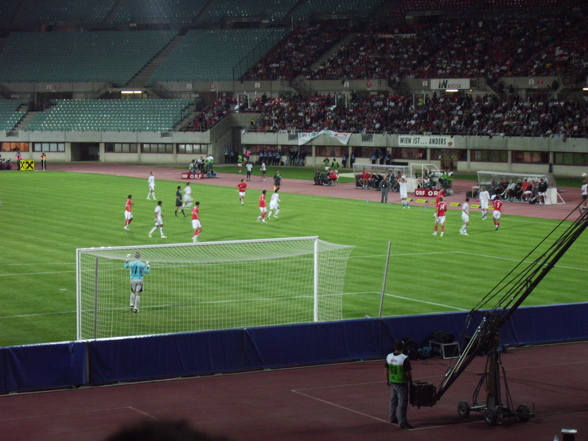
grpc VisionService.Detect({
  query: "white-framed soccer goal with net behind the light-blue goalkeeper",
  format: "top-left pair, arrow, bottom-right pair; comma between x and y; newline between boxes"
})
76,237 -> 353,340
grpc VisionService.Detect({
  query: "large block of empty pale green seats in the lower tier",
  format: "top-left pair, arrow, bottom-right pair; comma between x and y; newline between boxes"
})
27,99 -> 192,132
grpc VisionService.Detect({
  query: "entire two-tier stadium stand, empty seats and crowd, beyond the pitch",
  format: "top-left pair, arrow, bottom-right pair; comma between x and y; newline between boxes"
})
0,0 -> 588,174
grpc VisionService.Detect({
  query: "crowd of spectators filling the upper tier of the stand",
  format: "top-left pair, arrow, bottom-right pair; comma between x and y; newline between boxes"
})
242,15 -> 588,83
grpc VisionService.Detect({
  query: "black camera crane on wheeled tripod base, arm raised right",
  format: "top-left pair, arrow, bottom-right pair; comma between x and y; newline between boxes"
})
420,205 -> 588,426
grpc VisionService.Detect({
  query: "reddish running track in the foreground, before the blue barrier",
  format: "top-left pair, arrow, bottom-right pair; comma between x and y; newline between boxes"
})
0,342 -> 588,441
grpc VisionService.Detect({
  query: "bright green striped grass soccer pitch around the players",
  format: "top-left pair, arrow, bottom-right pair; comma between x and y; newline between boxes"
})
0,171 -> 588,346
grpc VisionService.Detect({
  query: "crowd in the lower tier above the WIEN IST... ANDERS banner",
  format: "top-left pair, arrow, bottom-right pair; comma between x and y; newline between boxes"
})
246,93 -> 588,137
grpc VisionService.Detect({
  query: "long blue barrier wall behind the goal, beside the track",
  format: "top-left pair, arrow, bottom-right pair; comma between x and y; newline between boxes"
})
0,303 -> 588,393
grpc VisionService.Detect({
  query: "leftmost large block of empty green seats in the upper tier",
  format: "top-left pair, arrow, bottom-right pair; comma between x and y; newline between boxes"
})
0,31 -> 177,86
